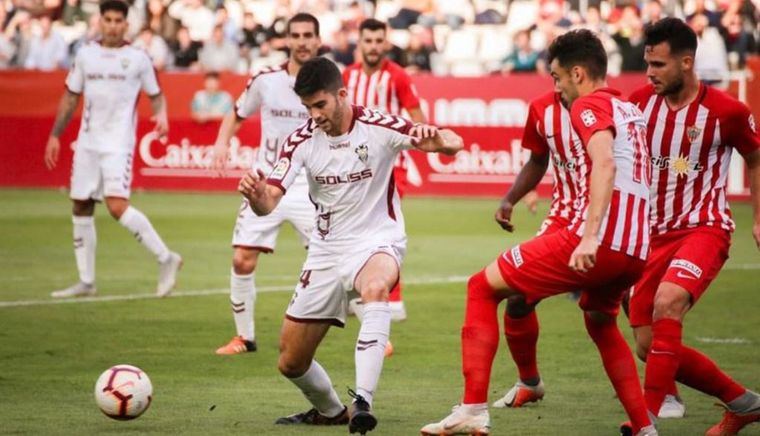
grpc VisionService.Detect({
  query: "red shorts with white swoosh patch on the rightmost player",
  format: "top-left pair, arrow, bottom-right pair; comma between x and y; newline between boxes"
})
629,227 -> 731,327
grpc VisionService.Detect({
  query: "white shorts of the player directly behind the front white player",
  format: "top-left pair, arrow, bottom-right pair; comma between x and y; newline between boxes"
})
232,192 -> 315,253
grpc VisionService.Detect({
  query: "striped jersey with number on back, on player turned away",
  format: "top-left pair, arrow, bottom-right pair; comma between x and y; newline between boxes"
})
570,88 -> 651,260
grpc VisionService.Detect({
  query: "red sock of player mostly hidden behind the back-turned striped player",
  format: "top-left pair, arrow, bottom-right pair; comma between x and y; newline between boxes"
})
504,310 -> 538,380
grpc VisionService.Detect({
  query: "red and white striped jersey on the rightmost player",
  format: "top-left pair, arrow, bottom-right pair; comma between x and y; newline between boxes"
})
631,85 -> 760,235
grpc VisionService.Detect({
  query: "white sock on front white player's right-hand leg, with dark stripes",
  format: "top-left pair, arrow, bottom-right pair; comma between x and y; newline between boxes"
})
354,302 -> 391,405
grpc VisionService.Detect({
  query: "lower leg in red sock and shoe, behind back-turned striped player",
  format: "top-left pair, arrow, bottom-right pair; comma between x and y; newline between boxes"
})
493,294 -> 544,408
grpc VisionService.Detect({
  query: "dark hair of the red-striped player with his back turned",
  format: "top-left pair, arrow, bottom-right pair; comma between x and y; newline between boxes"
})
549,29 -> 607,80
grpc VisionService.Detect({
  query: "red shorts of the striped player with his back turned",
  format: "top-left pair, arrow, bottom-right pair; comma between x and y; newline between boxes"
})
497,229 -> 644,316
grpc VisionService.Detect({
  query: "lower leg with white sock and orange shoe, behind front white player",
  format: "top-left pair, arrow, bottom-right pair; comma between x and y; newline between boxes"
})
216,245 -> 261,355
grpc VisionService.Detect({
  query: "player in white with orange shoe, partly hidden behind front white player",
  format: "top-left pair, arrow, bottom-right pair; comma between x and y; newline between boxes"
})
213,13 -> 322,355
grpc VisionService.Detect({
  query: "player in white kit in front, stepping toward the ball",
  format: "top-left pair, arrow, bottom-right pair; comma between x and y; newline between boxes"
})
238,58 -> 463,434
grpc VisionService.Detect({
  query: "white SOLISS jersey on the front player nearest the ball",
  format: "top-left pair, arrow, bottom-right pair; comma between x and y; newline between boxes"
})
267,106 -> 413,269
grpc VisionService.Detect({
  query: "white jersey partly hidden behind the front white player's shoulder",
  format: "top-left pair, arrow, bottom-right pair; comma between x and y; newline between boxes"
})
235,63 -> 309,190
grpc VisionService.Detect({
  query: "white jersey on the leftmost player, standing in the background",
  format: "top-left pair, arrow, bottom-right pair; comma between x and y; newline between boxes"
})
66,42 -> 161,152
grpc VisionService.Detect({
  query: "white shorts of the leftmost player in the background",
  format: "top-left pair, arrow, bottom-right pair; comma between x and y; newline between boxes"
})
69,148 -> 132,201
